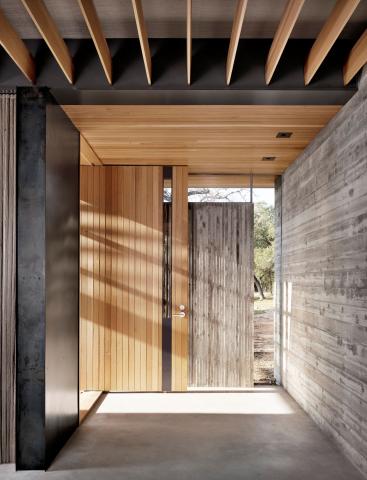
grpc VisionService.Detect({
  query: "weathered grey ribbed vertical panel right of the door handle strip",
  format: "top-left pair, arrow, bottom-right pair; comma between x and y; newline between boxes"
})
190,203 -> 254,388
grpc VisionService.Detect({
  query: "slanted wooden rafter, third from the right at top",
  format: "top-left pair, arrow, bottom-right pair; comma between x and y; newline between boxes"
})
265,0 -> 305,85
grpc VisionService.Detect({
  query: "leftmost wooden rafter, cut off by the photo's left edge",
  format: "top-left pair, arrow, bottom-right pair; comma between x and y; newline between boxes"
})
0,10 -> 36,83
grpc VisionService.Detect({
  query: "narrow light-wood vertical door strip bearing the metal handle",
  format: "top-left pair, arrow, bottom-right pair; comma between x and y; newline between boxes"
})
171,167 -> 191,391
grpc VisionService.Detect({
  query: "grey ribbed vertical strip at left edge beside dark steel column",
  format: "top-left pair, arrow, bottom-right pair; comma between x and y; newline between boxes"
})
0,92 -> 16,463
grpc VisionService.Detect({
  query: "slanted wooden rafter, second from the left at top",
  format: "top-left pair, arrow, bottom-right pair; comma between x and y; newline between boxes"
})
22,0 -> 74,84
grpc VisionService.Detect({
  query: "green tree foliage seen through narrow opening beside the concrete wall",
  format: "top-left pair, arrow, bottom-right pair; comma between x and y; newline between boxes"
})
254,203 -> 275,292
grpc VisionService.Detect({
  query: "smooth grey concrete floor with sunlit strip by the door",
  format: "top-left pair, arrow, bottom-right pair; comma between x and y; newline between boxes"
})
0,387 -> 363,480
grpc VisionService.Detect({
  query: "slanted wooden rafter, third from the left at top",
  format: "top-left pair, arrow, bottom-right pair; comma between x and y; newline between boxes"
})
78,0 -> 112,85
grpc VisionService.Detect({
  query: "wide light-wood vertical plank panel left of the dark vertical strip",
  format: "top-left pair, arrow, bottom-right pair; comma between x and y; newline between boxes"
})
80,166 -> 163,391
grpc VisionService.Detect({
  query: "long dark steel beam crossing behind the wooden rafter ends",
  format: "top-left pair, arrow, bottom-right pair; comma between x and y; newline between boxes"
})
0,39 -> 357,104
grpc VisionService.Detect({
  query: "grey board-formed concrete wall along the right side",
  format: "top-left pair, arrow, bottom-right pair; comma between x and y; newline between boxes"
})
276,68 -> 367,474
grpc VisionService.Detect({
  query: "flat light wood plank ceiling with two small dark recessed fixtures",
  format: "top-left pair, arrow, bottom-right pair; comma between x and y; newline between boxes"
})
63,105 -> 340,186
